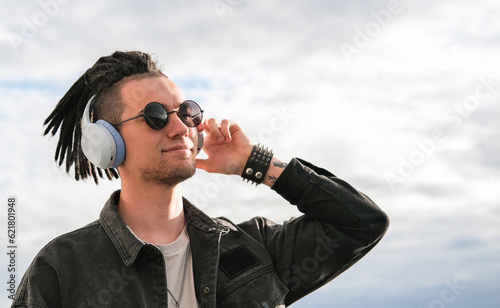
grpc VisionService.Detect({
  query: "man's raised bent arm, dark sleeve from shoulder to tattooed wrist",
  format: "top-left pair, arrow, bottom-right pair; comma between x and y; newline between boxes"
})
239,159 -> 388,305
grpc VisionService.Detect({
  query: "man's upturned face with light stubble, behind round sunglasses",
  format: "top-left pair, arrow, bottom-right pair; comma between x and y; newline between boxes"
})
119,76 -> 197,186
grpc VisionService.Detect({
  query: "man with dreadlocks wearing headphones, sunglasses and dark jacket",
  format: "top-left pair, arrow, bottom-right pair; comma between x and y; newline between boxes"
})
12,52 -> 388,308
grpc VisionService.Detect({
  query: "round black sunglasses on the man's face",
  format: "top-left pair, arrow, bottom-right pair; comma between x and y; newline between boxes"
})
113,100 -> 203,130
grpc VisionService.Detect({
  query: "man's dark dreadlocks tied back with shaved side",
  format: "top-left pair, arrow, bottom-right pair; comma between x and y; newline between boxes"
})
44,51 -> 165,184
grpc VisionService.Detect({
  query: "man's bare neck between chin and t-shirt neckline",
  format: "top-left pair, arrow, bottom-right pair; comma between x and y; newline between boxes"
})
118,179 -> 186,244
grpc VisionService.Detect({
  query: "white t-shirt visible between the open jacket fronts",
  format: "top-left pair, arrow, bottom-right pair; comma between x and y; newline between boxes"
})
156,227 -> 199,308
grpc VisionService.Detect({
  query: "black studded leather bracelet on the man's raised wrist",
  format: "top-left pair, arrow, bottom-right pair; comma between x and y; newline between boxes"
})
241,144 -> 274,185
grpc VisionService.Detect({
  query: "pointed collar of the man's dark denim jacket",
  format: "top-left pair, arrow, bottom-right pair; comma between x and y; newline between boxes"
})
99,190 -> 220,267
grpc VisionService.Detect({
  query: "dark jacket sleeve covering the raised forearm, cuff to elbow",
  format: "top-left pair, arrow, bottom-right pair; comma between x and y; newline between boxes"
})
273,159 -> 388,243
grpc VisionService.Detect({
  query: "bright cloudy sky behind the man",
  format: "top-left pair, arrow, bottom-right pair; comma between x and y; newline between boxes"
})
0,0 -> 500,308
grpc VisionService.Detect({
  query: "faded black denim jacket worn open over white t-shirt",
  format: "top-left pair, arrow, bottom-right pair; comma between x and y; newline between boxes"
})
12,159 -> 389,308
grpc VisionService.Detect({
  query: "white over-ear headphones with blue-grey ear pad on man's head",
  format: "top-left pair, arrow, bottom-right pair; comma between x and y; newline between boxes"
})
81,95 -> 203,169
